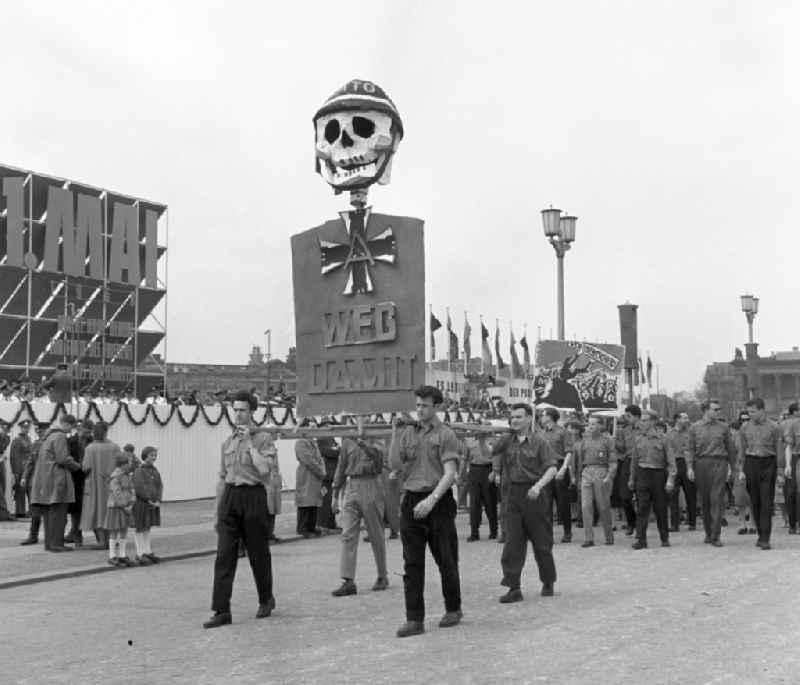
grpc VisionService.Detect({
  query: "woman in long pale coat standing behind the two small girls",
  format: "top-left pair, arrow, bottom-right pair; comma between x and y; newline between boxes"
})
81,421 -> 122,549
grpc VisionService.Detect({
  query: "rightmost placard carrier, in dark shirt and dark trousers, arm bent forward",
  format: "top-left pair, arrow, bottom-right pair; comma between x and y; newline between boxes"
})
492,403 -> 558,604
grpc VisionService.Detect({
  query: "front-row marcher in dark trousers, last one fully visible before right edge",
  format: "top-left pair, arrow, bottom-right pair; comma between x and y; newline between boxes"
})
738,397 -> 785,550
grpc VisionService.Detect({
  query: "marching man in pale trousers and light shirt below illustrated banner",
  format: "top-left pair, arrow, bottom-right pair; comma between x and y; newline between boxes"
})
573,416 -> 617,547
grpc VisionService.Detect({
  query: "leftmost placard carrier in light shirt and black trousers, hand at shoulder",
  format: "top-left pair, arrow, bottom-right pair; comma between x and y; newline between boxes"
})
203,390 -> 277,628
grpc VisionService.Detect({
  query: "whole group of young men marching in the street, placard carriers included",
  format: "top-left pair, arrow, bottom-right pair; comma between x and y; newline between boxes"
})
198,386 -> 800,637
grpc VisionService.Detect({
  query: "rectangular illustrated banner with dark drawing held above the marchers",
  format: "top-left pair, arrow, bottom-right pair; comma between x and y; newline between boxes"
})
533,340 -> 625,411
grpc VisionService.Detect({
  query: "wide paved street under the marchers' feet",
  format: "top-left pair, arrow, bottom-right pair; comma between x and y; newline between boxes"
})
0,504 -> 800,684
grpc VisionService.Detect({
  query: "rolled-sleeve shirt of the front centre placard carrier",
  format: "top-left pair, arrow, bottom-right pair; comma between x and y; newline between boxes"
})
390,416 -> 459,492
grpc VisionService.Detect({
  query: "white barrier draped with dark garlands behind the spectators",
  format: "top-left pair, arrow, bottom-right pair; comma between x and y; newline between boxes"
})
0,402 -> 297,502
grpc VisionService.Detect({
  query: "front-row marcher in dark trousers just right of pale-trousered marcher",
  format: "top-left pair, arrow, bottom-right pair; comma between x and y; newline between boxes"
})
628,409 -> 675,549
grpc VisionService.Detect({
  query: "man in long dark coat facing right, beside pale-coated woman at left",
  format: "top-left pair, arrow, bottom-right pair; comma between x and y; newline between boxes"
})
31,414 -> 81,552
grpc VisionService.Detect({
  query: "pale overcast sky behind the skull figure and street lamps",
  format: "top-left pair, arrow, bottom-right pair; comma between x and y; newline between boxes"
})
0,0 -> 800,392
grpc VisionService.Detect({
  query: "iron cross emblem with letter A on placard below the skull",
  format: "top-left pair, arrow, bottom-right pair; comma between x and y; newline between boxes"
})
319,207 -> 397,295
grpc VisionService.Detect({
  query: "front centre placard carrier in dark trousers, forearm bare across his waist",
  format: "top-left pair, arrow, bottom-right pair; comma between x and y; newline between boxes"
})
390,385 -> 462,637
